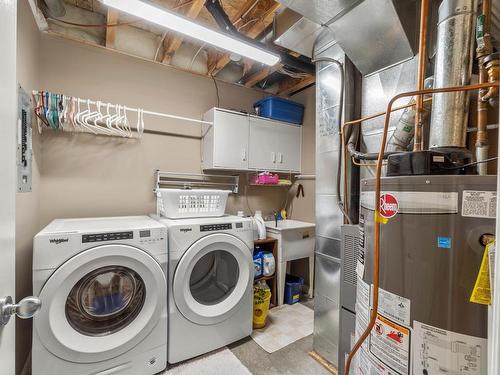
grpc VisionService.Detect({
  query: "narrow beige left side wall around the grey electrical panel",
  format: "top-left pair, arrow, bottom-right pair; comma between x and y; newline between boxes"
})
16,0 -> 41,373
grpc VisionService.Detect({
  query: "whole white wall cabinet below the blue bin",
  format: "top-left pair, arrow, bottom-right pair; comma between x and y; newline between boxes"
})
202,108 -> 302,173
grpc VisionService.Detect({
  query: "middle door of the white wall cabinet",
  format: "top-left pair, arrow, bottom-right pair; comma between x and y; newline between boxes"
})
248,117 -> 277,171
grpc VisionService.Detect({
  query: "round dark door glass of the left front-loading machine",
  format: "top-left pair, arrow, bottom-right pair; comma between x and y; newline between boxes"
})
66,266 -> 146,336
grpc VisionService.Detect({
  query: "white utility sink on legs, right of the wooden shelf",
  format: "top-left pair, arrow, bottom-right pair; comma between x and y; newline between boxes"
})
265,220 -> 316,305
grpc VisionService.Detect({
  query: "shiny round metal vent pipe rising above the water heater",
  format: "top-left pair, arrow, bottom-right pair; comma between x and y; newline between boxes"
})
429,0 -> 477,148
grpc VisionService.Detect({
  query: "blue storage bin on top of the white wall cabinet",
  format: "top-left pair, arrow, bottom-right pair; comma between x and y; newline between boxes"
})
254,96 -> 304,125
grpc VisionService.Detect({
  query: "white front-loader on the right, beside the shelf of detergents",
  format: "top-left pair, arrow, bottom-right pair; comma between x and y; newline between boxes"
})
151,216 -> 254,363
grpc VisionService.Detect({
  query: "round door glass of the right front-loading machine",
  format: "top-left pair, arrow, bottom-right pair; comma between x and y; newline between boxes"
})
189,250 -> 240,305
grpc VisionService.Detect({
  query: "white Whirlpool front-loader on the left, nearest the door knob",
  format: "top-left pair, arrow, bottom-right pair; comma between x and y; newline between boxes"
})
32,216 -> 168,375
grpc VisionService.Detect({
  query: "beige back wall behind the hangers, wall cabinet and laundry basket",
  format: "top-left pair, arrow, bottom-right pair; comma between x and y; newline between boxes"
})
40,35 -> 314,225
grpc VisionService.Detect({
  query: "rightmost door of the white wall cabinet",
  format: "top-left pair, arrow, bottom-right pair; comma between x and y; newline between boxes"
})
275,123 -> 302,172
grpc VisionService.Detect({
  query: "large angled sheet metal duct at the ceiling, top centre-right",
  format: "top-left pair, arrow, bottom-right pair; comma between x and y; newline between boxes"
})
279,0 -> 418,75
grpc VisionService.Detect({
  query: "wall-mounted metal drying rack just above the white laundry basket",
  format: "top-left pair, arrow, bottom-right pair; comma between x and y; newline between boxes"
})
154,170 -> 240,194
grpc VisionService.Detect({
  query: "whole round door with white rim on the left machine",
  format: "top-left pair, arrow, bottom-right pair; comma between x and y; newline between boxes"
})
34,245 -> 167,363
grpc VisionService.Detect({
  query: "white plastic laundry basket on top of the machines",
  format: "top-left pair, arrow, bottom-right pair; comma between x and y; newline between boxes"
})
156,189 -> 231,219
